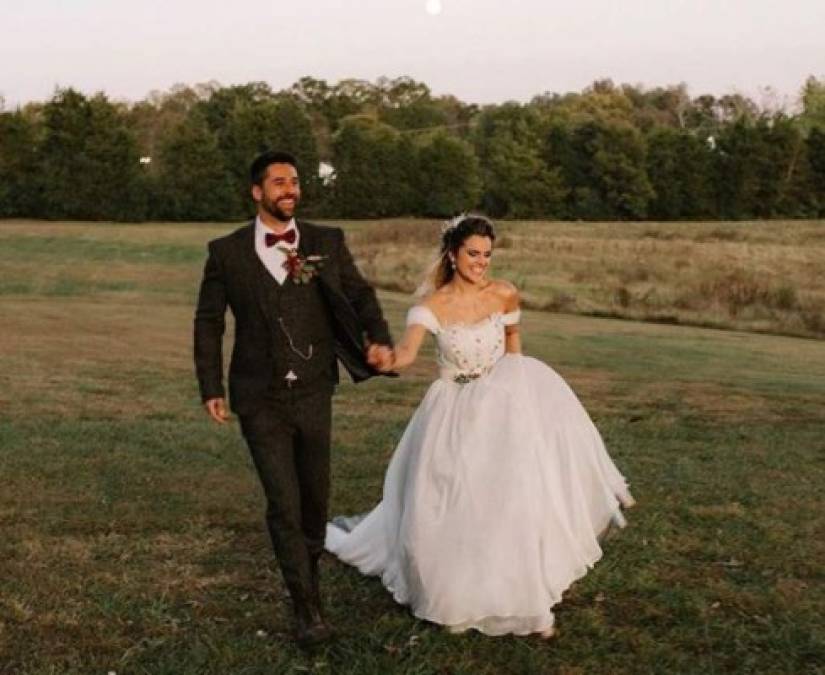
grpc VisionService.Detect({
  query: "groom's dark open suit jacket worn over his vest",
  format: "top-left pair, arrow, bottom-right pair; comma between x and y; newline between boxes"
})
195,221 -> 392,415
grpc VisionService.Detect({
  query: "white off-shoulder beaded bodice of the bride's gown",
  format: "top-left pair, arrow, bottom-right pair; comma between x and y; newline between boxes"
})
407,305 -> 521,384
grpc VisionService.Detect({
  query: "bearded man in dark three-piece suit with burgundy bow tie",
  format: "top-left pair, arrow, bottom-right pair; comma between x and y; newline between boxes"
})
195,151 -> 391,644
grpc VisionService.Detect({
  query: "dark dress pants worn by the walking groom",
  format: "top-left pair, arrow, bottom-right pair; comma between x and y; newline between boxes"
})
240,385 -> 333,604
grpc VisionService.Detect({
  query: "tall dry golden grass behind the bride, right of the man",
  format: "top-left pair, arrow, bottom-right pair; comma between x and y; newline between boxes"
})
348,220 -> 825,337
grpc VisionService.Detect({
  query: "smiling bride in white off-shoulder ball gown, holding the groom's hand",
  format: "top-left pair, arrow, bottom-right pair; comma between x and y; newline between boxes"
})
326,215 -> 633,637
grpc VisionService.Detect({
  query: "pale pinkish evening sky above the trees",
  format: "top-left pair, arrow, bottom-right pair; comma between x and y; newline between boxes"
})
0,0 -> 825,109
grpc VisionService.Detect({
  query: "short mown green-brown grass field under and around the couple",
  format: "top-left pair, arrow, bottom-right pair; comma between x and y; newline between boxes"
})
0,222 -> 825,675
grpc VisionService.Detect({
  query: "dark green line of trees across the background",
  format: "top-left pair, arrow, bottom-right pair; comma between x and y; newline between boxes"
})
0,77 -> 825,221
